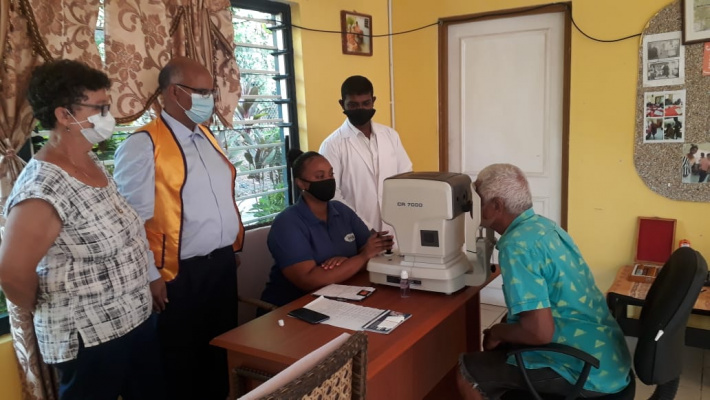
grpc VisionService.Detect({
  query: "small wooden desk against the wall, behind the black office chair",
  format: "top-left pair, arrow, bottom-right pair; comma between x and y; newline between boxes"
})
606,265 -> 710,349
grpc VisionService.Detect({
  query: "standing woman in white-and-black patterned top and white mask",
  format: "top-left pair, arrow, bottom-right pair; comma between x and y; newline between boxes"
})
0,60 -> 164,400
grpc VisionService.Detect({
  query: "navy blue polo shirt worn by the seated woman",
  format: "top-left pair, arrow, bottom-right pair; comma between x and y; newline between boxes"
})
261,199 -> 370,306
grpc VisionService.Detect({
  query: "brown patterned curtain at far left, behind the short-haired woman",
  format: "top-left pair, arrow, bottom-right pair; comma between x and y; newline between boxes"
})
0,0 -> 102,400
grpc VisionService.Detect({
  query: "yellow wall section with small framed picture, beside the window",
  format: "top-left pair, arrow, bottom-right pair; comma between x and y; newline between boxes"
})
290,0 -> 391,151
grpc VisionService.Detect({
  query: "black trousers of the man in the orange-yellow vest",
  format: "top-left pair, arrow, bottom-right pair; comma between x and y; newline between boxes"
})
158,247 -> 237,400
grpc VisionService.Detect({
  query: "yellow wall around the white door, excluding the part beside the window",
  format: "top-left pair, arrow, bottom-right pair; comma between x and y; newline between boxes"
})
392,0 -> 710,290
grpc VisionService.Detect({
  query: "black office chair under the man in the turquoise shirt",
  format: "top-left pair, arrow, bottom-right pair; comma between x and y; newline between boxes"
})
504,247 -> 708,400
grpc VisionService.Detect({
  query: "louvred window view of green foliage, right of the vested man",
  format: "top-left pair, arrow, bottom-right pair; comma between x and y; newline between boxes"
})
229,7 -> 288,225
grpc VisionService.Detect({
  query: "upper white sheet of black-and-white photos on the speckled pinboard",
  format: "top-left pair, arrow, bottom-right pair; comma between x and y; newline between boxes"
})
641,32 -> 685,87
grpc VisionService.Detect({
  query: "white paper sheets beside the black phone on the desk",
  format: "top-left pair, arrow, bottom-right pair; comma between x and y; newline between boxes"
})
304,297 -> 412,333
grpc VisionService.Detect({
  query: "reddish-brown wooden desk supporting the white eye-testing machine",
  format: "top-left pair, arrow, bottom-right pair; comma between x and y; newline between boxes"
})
211,272 -> 498,400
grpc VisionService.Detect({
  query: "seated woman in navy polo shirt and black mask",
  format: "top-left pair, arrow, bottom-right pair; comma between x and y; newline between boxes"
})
261,150 -> 392,306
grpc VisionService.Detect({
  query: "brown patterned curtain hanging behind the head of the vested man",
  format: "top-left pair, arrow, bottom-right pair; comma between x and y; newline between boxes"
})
105,0 -> 241,126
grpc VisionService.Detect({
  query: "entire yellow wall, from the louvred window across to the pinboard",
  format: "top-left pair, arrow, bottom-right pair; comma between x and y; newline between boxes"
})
291,0 -> 710,290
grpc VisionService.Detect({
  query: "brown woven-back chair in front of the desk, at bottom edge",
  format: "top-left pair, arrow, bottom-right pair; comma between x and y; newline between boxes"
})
231,332 -> 367,400
